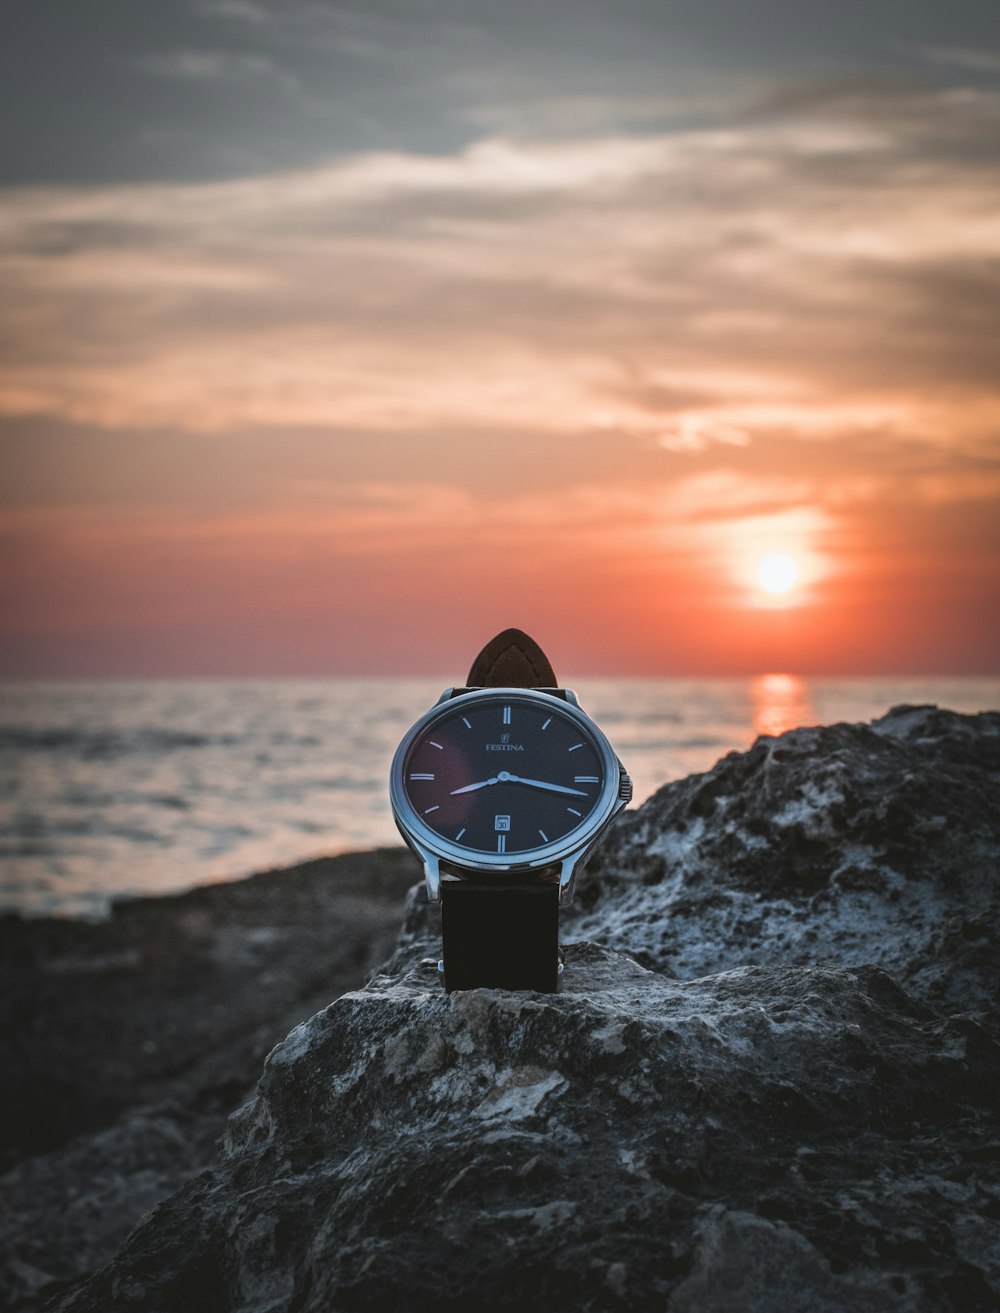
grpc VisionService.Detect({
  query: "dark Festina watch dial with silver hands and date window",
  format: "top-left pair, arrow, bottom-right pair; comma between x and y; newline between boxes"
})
403,695 -> 604,856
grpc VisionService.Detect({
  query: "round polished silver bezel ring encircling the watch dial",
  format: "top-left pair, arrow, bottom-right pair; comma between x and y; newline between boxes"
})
388,688 -> 622,874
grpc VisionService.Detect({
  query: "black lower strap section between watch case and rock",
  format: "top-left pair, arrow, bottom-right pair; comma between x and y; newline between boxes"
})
441,880 -> 559,994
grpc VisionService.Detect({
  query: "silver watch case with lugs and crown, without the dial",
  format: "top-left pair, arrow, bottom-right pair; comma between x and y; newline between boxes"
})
388,688 -> 633,903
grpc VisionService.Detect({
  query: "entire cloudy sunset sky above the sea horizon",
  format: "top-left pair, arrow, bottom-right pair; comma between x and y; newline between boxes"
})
0,0 -> 1000,680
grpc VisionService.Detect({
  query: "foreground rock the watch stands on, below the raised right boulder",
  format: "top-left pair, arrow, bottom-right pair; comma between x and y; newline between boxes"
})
54,944 -> 1000,1313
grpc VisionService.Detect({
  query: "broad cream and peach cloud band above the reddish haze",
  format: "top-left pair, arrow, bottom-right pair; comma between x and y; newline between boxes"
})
0,79 -> 1000,452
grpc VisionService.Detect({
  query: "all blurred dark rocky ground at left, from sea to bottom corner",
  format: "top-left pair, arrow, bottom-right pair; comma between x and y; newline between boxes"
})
0,848 -> 417,1308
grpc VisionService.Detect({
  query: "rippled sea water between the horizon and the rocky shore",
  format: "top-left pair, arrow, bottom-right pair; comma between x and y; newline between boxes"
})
0,675 -> 1000,916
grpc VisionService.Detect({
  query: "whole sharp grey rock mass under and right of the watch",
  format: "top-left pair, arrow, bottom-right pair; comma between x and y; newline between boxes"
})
1,708 -> 1000,1313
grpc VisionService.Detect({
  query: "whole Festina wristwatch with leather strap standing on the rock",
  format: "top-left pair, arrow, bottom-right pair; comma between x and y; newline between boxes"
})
390,629 -> 633,993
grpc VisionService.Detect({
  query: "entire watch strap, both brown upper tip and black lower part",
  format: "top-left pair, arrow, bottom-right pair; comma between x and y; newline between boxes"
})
441,629 -> 562,994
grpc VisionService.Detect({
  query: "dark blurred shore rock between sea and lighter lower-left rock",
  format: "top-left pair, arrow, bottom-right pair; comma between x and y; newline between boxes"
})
0,848 -> 417,1169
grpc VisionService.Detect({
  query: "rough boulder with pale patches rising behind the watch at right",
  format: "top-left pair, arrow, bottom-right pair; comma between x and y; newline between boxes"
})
392,706 -> 1000,1025
